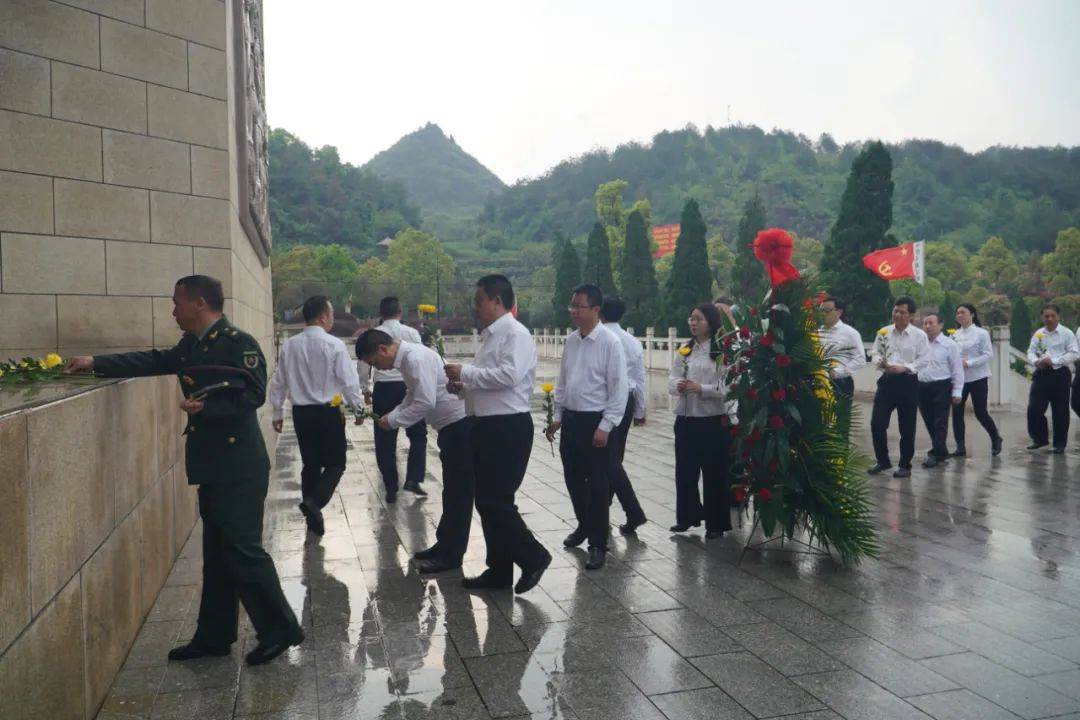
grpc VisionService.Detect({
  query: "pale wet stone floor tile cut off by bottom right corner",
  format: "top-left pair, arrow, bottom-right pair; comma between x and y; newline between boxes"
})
921,653 -> 1080,720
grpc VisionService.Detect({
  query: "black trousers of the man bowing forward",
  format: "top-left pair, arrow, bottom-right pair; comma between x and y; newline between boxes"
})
435,418 -> 476,562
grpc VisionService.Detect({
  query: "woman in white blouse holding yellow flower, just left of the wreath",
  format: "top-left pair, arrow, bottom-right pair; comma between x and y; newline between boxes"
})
667,302 -> 731,540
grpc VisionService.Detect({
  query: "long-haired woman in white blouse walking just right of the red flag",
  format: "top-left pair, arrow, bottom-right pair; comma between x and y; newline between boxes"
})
953,302 -> 1001,458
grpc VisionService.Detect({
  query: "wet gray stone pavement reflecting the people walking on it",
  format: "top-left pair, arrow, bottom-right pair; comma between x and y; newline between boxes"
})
97,367 -> 1080,720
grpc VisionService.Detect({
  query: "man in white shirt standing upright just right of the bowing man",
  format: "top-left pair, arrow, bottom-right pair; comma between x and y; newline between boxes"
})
445,275 -> 551,593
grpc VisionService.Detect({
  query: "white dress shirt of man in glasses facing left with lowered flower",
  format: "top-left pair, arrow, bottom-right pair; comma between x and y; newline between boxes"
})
555,325 -> 630,433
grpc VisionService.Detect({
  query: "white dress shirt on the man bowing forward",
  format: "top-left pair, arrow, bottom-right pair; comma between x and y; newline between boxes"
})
387,342 -> 465,430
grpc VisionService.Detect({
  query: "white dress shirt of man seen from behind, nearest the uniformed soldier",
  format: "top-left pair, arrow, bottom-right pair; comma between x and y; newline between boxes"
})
269,325 -> 364,420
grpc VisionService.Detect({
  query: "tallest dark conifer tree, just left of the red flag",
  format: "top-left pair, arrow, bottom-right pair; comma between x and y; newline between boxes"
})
821,141 -> 896,337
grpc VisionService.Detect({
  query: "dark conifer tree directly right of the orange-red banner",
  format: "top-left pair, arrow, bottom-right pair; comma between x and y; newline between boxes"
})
657,200 -> 713,335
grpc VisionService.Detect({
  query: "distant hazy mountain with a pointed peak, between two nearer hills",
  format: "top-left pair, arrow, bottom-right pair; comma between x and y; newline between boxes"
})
364,123 -> 507,216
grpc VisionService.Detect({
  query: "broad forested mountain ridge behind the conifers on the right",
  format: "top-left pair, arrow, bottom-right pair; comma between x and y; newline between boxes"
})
480,126 -> 1080,253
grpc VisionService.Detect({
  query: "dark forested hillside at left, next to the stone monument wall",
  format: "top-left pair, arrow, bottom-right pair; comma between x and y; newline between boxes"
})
269,128 -> 420,255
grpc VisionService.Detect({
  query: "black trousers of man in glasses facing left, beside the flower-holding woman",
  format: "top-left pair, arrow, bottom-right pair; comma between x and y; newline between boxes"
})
558,410 -> 613,551
